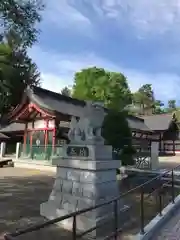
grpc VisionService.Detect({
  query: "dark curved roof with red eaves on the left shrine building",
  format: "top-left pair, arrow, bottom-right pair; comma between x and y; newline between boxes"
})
8,87 -> 86,121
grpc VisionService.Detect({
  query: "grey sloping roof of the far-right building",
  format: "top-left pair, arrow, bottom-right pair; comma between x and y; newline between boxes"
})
142,114 -> 172,130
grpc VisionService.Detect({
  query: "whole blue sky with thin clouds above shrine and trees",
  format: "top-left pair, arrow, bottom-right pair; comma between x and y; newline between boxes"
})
29,0 -> 180,104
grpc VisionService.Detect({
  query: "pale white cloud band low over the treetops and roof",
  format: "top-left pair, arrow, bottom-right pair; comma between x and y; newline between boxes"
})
30,47 -> 180,100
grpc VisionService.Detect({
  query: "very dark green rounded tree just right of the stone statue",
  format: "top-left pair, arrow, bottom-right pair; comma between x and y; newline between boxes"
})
102,110 -> 135,165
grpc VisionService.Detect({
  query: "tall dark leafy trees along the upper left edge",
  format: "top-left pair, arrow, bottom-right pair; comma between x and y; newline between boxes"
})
0,0 -> 44,114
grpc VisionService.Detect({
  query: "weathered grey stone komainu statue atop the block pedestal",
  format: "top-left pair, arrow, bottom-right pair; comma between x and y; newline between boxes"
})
68,101 -> 105,144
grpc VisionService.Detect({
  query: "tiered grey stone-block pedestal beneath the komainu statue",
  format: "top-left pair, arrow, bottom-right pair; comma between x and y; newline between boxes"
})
40,145 -> 124,238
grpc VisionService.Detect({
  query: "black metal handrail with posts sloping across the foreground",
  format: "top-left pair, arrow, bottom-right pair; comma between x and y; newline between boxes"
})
4,164 -> 180,240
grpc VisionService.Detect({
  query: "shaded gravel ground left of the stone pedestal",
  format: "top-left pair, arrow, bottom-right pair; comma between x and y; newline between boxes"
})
0,168 -> 74,240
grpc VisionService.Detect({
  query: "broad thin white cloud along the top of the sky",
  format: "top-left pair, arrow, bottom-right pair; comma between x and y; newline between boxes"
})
39,0 -> 180,38
